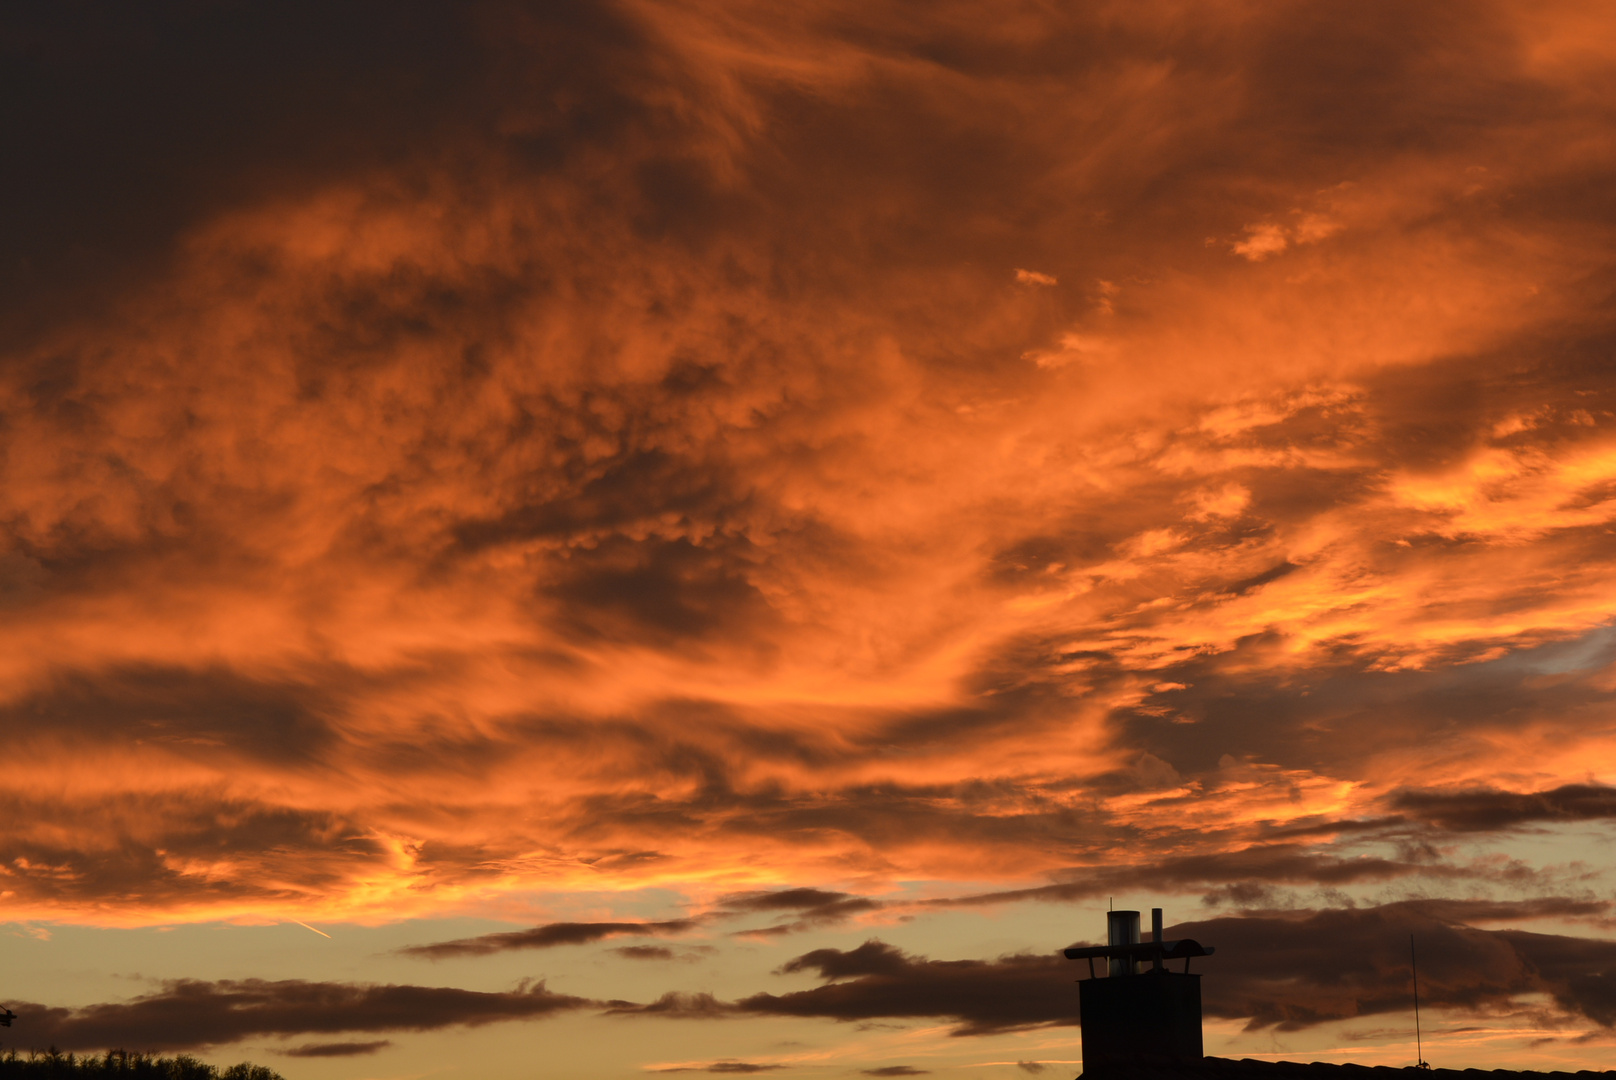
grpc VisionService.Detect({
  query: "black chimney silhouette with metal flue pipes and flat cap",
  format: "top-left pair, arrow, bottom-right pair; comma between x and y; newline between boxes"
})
1067,907 -> 1214,1072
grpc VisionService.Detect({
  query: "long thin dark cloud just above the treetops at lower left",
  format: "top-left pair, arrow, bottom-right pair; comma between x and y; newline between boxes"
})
15,978 -> 593,1053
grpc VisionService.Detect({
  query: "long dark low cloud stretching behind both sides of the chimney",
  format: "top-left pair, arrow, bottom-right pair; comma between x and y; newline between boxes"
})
609,897 -> 1616,1034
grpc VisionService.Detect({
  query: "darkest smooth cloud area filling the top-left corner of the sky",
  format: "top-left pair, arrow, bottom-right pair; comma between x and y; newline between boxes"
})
0,0 -> 632,337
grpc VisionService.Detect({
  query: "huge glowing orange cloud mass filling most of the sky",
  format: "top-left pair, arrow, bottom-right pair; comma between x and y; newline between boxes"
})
0,12 -> 1616,1041
